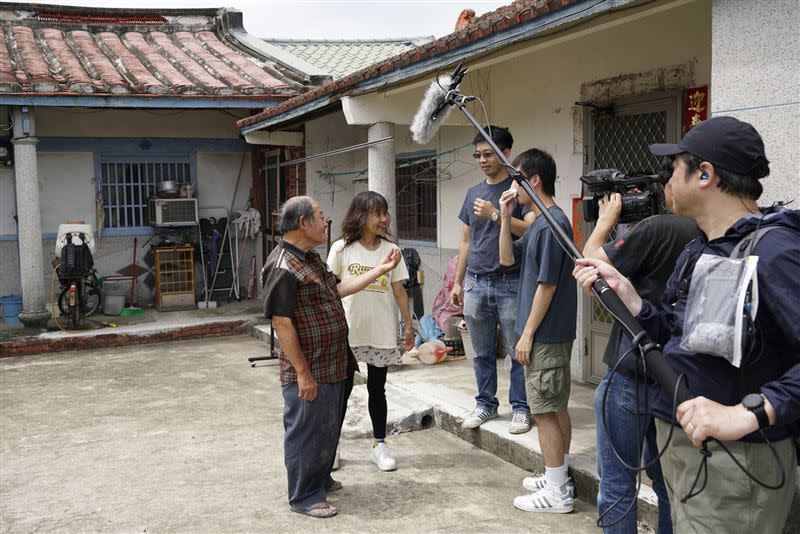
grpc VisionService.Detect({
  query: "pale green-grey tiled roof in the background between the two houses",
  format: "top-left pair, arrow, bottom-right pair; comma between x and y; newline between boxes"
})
264,36 -> 434,79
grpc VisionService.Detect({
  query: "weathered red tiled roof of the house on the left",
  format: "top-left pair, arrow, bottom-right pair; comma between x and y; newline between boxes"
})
0,3 -> 303,97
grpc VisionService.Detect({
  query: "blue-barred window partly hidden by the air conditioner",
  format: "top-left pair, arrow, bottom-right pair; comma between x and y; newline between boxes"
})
98,158 -> 191,228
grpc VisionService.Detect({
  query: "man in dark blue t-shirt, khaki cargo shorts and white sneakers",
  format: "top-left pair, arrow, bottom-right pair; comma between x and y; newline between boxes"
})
499,148 -> 578,513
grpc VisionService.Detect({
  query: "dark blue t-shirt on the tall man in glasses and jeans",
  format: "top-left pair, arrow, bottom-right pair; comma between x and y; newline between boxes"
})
458,176 -> 531,274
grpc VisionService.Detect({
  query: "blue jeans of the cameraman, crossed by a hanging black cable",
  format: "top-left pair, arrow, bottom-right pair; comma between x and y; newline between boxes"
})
594,369 -> 672,534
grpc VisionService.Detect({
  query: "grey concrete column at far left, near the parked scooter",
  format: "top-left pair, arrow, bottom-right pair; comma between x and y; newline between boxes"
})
11,108 -> 50,328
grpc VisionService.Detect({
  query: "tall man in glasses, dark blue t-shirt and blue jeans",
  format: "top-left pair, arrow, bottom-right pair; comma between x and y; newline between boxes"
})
450,126 -> 533,434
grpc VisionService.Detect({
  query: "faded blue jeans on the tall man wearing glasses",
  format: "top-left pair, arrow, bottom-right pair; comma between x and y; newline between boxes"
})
464,273 -> 530,413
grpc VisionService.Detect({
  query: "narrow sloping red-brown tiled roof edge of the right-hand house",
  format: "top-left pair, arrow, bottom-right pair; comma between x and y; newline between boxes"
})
236,0 -> 584,128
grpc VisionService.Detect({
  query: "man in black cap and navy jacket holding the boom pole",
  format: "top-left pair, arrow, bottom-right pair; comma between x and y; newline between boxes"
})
574,117 -> 800,532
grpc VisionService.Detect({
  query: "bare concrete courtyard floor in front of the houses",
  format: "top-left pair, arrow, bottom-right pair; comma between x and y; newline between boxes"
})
0,336 -> 598,534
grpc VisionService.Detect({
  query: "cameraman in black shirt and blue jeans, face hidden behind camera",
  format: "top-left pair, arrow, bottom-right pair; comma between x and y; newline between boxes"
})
583,187 -> 699,534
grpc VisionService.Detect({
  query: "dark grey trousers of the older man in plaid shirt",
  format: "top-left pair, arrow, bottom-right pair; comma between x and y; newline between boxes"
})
283,380 -> 345,509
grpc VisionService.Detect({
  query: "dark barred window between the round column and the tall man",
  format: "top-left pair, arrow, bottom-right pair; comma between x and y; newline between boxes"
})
396,152 -> 437,241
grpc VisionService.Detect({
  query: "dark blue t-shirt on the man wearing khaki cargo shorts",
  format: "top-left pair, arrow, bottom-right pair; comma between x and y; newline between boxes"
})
514,206 -> 578,343
